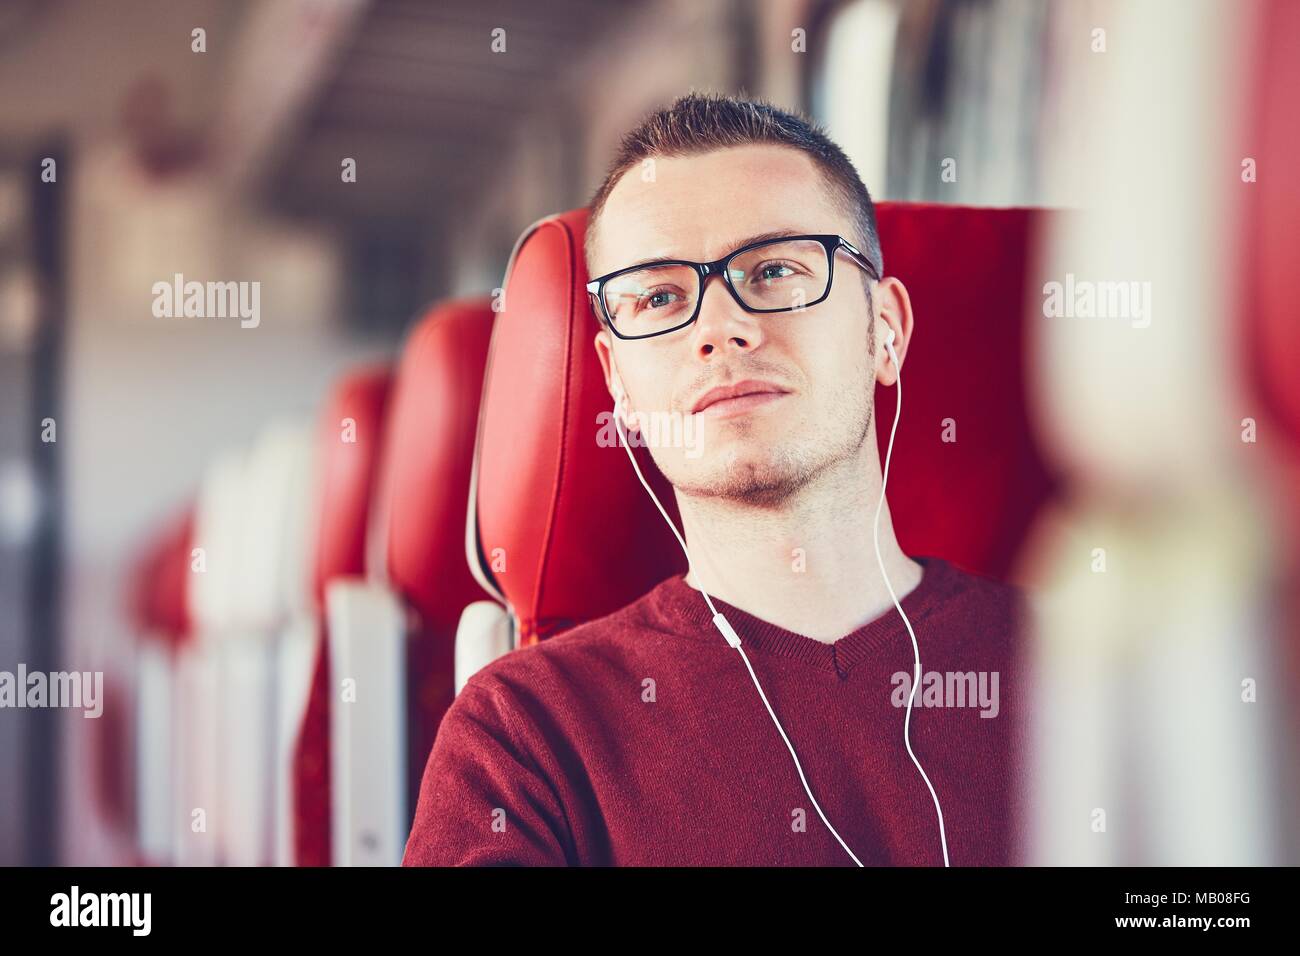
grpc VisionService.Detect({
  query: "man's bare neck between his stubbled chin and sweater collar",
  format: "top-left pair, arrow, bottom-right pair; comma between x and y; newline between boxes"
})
677,441 -> 922,644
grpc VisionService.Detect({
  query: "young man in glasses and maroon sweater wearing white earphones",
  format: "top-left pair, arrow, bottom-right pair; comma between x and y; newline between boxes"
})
404,95 -> 1022,866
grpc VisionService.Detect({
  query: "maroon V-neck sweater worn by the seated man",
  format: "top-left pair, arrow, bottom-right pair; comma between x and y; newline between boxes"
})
403,558 -> 1024,866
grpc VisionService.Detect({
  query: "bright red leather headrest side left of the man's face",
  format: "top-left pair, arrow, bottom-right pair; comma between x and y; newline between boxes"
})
472,209 -> 686,645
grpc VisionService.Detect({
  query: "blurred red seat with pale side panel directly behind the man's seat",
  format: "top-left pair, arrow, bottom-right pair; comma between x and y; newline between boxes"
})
326,298 -> 494,865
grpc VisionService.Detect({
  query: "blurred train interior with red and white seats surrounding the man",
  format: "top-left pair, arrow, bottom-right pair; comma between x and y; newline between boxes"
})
0,0 -> 1300,866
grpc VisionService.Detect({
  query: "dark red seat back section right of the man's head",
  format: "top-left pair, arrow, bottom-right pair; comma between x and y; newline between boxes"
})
876,203 -> 1057,578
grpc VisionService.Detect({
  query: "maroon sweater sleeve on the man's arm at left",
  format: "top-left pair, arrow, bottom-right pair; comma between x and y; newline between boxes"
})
402,680 -> 573,866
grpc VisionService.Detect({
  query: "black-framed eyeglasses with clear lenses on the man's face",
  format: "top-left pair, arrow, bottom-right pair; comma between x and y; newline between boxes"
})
586,235 -> 880,338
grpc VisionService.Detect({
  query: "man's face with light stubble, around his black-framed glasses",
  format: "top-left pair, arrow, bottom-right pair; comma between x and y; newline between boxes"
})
589,144 -> 875,505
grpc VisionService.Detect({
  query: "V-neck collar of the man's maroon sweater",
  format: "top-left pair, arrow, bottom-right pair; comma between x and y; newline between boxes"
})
646,555 -> 958,678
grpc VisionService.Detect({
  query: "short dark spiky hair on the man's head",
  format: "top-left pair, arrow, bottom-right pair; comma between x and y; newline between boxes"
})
584,92 -> 884,276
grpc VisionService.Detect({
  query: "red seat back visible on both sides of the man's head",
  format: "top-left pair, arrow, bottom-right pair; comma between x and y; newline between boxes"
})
475,203 -> 1054,644
